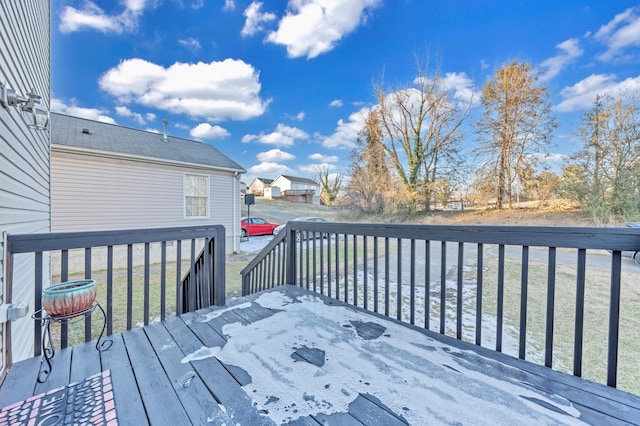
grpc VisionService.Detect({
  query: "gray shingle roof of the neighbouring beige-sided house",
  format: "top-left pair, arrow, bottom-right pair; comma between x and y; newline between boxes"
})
50,113 -> 246,173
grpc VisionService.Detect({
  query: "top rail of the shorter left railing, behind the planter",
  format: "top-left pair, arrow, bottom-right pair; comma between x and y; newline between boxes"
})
7,225 -> 224,254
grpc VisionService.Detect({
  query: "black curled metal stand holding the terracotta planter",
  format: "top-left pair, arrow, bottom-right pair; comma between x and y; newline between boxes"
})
32,302 -> 113,383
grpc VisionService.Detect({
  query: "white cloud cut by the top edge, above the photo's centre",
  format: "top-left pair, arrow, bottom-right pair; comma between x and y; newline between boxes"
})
267,0 -> 381,59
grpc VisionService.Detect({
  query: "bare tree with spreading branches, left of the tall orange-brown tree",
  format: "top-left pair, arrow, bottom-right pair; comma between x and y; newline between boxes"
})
374,59 -> 472,210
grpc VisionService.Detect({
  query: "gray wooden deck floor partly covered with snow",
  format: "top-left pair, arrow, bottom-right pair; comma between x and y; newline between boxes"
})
0,286 -> 640,425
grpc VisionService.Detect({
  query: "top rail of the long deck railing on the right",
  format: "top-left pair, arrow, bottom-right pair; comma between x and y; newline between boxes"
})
282,221 -> 640,250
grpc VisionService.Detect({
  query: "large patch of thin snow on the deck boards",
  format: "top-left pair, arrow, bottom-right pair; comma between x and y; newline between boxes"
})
210,291 -> 582,424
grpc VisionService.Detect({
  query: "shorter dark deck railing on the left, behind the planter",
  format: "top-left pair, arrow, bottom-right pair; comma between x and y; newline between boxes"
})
6,225 -> 225,362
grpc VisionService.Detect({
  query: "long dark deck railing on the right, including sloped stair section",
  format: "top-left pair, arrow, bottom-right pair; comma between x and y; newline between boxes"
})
241,221 -> 640,387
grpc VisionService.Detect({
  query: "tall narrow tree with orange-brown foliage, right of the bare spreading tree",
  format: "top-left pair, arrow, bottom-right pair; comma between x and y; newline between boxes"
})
476,61 -> 557,209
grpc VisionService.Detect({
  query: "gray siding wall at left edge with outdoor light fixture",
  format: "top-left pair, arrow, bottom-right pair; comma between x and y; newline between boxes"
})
0,0 -> 50,364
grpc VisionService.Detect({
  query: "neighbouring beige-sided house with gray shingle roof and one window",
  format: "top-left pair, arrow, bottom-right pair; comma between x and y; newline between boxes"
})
51,113 -> 245,251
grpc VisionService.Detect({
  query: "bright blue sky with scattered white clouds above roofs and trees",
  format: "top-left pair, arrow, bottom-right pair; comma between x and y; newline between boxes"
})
51,0 -> 640,183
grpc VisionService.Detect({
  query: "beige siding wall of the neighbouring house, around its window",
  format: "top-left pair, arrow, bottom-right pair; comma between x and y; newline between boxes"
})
51,151 -> 240,252
